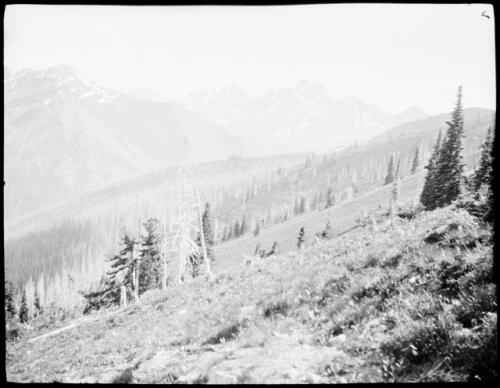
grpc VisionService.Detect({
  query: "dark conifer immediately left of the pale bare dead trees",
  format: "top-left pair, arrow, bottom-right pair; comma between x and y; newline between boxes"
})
139,218 -> 162,294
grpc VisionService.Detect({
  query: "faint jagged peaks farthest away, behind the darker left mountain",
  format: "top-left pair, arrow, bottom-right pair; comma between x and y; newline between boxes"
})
182,81 -> 427,155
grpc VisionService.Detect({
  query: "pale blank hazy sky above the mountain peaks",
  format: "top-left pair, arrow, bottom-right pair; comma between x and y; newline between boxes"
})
4,4 -> 495,113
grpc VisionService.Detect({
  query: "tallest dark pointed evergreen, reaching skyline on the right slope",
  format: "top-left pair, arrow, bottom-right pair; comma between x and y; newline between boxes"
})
435,86 -> 465,207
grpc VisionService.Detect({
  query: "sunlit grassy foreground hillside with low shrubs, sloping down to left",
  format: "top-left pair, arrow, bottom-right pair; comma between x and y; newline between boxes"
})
6,200 -> 497,384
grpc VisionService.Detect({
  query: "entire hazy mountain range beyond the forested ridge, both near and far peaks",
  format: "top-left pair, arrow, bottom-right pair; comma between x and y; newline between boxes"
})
4,65 -> 490,224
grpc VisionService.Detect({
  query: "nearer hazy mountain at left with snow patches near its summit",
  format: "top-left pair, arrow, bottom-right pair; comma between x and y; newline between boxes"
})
4,66 -> 243,218
